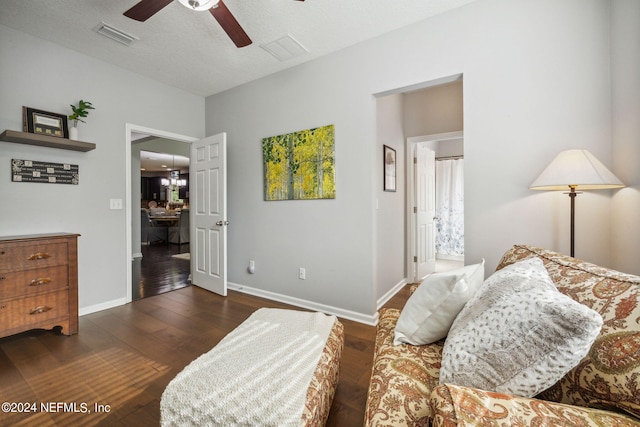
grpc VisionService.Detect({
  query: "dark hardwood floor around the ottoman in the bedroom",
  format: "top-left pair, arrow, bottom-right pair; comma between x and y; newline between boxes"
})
0,276 -> 408,427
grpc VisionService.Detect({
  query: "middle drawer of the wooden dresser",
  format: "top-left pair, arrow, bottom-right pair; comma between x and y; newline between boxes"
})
0,265 -> 69,300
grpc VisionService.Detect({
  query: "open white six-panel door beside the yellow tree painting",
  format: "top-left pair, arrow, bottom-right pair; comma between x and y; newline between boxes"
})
189,133 -> 228,296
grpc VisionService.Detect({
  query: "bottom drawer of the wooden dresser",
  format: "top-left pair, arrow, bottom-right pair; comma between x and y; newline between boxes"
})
0,291 -> 69,330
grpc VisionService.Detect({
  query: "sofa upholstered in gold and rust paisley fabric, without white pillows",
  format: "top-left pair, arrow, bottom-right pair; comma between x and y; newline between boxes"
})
364,245 -> 640,427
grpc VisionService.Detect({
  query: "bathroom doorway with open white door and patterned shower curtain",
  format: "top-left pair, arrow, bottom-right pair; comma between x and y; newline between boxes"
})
405,131 -> 464,282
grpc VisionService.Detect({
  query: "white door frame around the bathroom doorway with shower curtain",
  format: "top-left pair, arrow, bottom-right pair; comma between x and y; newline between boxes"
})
404,131 -> 464,283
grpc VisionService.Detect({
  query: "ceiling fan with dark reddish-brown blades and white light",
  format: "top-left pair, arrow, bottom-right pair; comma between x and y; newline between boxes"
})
124,0 -> 304,47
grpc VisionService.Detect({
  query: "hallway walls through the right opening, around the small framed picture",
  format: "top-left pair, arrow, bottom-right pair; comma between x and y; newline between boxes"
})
374,74 -> 464,307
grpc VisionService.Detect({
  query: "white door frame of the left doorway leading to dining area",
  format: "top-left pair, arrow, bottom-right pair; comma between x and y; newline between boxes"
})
125,123 -> 200,303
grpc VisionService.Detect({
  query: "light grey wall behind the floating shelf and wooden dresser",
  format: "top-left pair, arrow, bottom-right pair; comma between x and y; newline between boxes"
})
0,25 -> 204,312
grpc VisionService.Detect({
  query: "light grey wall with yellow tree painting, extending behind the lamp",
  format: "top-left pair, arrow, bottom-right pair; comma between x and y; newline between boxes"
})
206,0 -> 611,316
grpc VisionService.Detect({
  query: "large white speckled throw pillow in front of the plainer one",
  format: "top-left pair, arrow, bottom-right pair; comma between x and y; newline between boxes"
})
440,258 -> 602,397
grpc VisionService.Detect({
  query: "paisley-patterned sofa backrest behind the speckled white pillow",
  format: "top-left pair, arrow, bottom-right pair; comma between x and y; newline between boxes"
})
496,245 -> 640,419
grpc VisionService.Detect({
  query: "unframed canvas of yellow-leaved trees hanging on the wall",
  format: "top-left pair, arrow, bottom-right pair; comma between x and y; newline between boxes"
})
262,125 -> 336,200
